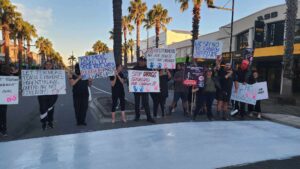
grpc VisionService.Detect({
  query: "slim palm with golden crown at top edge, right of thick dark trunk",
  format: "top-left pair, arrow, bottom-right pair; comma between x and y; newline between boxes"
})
128,0 -> 147,58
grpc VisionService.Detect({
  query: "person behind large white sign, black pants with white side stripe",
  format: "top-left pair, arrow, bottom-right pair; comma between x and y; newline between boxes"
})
38,61 -> 58,130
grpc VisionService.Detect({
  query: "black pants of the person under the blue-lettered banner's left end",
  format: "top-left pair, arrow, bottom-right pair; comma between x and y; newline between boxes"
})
73,95 -> 89,124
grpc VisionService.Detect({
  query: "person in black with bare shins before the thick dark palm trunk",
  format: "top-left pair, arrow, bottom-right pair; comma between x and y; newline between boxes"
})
109,64 -> 126,123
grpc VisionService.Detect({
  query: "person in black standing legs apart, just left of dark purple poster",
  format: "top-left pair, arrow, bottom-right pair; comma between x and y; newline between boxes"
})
169,64 -> 188,116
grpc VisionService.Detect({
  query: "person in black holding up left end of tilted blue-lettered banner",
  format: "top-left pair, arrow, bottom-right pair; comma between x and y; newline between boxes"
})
69,63 -> 92,126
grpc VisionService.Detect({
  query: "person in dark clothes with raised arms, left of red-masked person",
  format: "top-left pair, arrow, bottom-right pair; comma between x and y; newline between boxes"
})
216,62 -> 233,120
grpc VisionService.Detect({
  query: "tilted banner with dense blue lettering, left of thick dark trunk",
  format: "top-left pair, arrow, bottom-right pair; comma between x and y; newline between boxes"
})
78,53 -> 116,80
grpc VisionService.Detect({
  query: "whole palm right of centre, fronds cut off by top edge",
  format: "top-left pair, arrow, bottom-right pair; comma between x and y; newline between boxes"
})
175,0 -> 213,60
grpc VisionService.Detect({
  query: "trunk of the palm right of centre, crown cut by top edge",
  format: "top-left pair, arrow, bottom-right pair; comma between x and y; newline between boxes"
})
192,0 -> 202,60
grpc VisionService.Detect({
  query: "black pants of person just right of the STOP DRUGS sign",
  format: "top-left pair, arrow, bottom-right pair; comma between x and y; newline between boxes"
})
150,93 -> 167,117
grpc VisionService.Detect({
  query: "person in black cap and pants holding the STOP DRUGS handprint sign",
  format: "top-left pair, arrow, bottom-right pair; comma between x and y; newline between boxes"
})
133,57 -> 155,123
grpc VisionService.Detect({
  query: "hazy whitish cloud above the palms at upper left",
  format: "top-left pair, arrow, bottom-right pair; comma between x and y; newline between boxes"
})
14,3 -> 53,35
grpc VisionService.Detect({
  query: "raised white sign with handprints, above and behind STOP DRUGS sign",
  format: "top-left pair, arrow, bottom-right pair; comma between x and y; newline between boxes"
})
146,48 -> 176,69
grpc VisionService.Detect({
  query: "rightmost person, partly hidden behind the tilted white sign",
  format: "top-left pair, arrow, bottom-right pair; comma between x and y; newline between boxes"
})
248,70 -> 262,119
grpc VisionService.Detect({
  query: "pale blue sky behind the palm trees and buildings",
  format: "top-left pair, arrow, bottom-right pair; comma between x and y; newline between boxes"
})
11,0 -> 285,63
